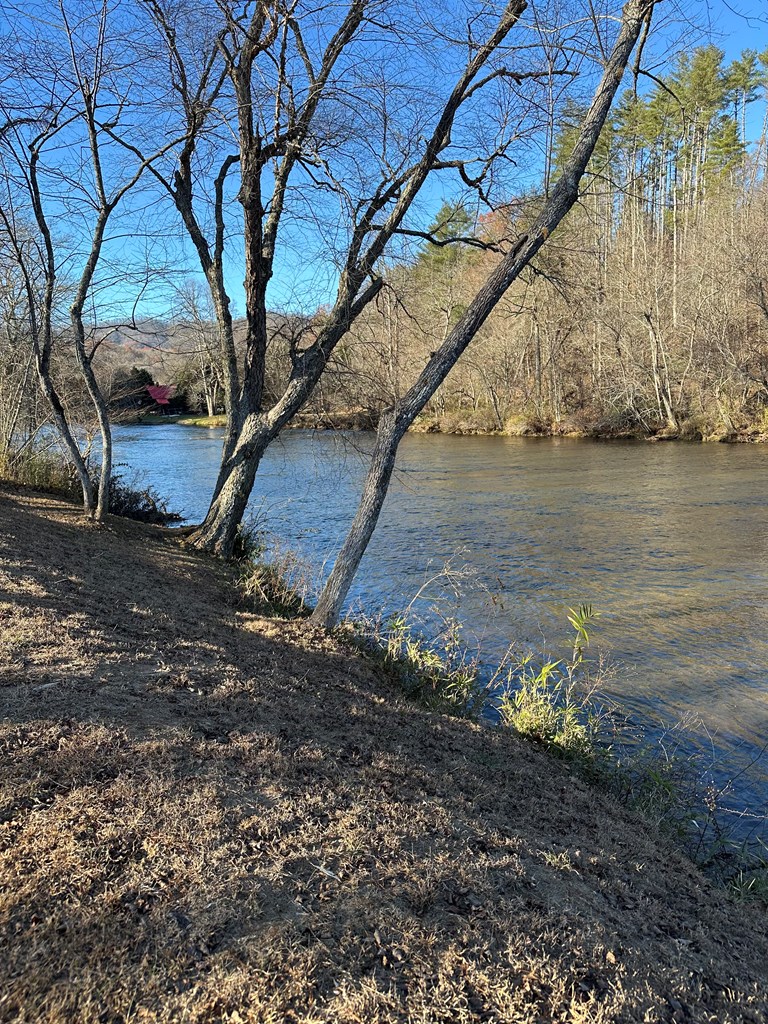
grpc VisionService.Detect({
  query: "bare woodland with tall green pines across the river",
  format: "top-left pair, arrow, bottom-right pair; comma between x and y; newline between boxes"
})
2,37 -> 768,444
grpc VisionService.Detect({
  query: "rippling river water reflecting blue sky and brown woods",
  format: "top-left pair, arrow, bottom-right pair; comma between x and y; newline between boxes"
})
115,424 -> 768,813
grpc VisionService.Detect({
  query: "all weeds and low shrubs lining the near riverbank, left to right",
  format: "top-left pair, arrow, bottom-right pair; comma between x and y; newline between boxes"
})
0,449 -> 768,902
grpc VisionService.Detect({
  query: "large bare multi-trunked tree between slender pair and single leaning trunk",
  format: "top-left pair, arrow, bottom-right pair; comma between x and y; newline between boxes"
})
137,0 -> 570,556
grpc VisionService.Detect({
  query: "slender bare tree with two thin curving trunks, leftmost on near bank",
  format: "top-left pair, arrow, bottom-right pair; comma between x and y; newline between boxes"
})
0,0 -> 182,519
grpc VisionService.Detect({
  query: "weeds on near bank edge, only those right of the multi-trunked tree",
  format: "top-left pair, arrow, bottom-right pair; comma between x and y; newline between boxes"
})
236,544 -> 768,906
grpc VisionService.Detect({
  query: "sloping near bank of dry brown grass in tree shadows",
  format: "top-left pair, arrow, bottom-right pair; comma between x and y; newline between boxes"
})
0,490 -> 768,1024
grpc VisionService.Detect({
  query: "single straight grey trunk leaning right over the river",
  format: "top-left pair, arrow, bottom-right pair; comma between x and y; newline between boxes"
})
310,0 -> 655,627
